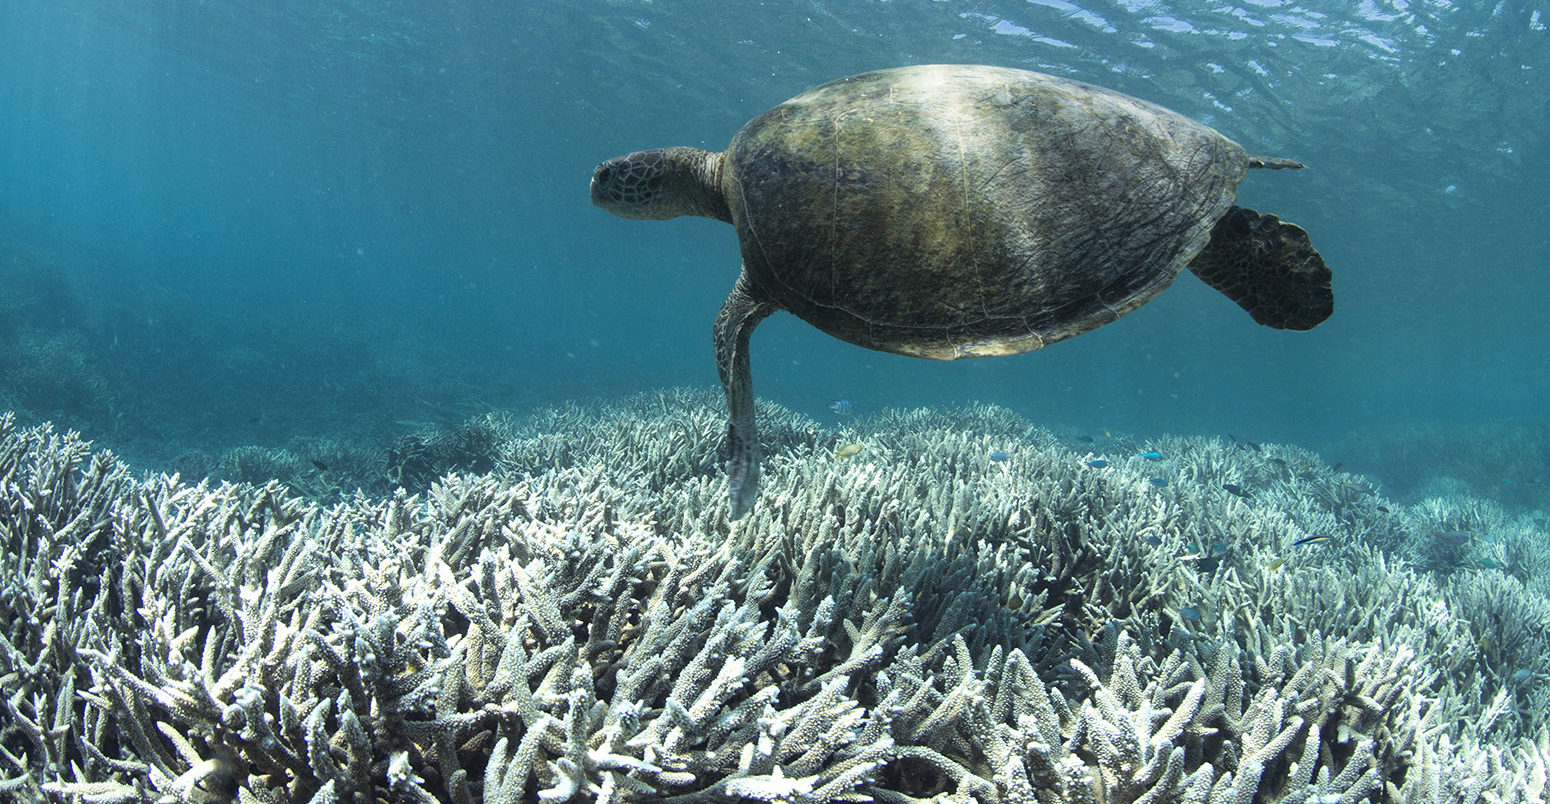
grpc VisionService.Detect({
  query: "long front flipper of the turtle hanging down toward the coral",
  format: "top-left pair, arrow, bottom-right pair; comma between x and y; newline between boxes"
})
716,274 -> 775,519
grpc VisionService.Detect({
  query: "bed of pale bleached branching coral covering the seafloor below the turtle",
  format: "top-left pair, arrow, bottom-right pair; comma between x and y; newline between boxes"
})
0,392 -> 1550,804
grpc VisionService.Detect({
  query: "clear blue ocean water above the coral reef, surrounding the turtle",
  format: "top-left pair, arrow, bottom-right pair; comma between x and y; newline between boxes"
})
0,0 -> 1550,488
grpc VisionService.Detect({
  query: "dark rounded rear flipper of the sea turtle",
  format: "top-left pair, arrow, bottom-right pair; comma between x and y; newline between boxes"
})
1189,206 -> 1335,330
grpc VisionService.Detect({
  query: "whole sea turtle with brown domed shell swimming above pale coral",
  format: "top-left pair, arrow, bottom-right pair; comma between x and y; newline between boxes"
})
592,65 -> 1335,519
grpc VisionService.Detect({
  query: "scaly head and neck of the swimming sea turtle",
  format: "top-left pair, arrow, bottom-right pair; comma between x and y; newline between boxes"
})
592,147 -> 732,222
